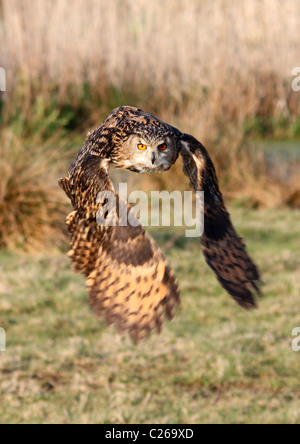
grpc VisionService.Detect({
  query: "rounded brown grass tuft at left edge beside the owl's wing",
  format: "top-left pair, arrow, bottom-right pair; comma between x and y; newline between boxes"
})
0,130 -> 65,248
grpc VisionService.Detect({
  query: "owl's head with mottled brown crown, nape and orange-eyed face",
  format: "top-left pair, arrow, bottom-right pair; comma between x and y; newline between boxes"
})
78,106 -> 183,173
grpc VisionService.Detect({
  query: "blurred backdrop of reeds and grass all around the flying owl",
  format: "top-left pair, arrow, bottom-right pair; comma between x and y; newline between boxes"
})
0,0 -> 300,423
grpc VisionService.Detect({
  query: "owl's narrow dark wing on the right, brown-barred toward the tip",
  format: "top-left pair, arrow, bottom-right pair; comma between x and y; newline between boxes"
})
181,134 -> 260,309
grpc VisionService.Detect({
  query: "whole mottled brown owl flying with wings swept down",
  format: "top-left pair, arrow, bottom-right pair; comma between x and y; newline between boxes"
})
59,106 -> 260,341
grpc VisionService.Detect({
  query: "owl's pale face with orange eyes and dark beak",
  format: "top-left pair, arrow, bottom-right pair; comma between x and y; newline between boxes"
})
116,134 -> 178,173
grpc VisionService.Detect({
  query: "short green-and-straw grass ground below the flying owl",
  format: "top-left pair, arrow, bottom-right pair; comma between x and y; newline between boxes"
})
0,208 -> 300,423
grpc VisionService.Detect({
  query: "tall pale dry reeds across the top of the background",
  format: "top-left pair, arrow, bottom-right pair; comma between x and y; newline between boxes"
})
0,0 -> 300,128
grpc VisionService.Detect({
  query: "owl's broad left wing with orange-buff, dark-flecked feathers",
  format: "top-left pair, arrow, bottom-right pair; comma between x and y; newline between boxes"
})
59,154 -> 180,341
